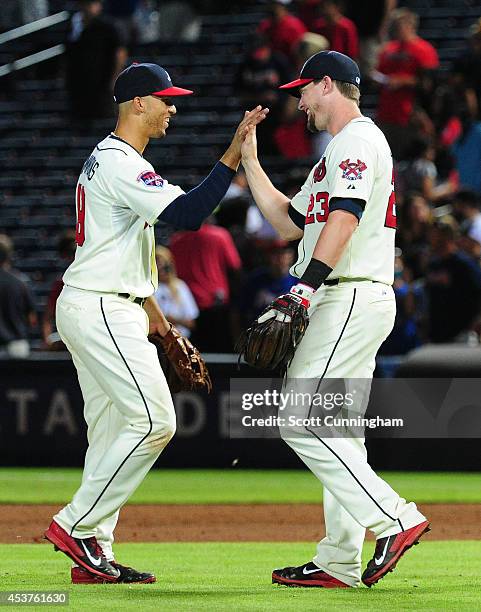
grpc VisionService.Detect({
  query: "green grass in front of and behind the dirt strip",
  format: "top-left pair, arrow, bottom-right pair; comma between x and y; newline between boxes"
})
0,468 -> 481,612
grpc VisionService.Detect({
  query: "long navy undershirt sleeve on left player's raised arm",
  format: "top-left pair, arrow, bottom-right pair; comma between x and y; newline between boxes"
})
158,161 -> 235,230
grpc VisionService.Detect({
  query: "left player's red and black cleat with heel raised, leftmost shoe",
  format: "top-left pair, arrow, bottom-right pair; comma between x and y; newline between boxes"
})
45,521 -> 120,582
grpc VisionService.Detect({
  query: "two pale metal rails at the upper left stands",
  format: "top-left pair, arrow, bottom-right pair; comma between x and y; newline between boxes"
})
0,11 -> 70,77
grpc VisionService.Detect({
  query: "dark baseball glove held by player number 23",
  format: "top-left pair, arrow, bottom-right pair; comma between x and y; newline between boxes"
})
236,293 -> 309,374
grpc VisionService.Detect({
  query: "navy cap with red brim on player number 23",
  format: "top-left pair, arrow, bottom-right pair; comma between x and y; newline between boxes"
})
279,51 -> 361,98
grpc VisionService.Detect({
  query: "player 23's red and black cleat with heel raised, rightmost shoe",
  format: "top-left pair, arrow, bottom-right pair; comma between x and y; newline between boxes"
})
362,521 -> 429,587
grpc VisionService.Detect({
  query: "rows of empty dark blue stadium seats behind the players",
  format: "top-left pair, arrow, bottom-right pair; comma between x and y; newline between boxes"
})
0,0 -> 481,350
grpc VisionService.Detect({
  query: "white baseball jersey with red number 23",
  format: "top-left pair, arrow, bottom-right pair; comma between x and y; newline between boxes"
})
291,117 -> 396,284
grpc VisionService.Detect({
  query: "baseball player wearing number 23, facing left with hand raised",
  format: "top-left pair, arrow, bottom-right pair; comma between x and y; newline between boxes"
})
242,51 -> 429,588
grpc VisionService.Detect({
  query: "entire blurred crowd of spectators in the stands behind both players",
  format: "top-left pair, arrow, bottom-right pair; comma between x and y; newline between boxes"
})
0,0 -> 481,356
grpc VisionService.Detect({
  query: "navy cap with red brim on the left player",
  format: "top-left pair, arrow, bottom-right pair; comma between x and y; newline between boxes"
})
114,64 -> 194,104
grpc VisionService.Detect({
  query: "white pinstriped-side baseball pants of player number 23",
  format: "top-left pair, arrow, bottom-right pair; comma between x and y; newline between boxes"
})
281,281 -> 425,586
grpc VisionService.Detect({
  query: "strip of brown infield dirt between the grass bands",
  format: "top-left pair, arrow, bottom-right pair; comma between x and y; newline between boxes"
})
0,504 -> 481,544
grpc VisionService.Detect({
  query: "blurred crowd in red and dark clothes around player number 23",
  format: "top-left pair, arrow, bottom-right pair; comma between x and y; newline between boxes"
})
239,0 -> 481,355
